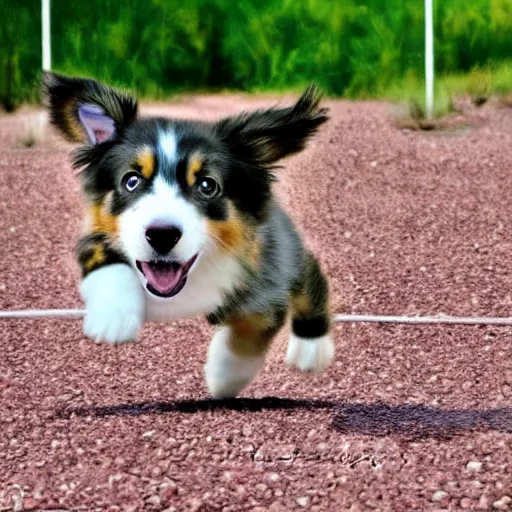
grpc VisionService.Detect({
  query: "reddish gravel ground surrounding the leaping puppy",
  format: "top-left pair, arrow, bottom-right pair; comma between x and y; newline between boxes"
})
0,96 -> 512,511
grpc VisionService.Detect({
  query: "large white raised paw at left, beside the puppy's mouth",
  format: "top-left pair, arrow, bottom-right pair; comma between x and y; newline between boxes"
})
80,263 -> 144,343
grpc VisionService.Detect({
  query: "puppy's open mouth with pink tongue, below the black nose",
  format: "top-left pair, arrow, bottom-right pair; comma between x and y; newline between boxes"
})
135,254 -> 197,298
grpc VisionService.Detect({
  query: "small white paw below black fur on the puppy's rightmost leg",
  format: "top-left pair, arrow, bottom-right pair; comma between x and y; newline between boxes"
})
285,333 -> 334,372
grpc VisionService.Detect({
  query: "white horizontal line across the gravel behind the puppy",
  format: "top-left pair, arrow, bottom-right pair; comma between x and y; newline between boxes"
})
0,309 -> 512,325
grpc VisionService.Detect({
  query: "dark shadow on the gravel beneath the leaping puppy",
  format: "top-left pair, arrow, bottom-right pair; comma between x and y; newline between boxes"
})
61,397 -> 512,440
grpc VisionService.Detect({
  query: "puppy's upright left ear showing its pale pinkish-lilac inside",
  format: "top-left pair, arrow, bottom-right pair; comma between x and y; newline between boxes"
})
42,71 -> 137,146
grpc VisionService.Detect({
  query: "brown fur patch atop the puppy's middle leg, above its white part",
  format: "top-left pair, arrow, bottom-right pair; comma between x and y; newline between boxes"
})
229,315 -> 272,357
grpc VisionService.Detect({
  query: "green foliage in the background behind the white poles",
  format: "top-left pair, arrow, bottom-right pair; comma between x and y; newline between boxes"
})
0,0 -> 512,109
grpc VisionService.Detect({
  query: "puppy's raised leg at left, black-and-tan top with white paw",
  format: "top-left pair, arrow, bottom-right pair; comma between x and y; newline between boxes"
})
77,233 -> 145,343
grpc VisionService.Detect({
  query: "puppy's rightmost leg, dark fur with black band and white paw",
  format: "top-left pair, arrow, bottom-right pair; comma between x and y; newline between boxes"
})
285,252 -> 335,372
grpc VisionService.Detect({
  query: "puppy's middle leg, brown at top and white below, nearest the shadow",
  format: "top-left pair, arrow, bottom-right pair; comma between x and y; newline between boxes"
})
204,312 -> 285,398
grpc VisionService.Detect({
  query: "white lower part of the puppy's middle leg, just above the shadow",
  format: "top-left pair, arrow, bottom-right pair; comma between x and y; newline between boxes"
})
204,327 -> 265,398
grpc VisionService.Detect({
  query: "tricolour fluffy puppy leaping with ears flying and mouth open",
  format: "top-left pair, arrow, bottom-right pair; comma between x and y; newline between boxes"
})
43,72 -> 334,398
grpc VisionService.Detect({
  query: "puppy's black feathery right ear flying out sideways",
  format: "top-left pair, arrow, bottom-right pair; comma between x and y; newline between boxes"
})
216,85 -> 329,166
